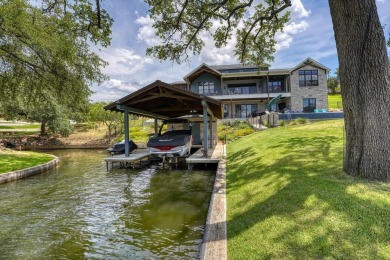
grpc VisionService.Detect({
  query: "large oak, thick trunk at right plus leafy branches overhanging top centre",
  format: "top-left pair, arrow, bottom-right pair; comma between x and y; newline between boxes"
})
146,0 -> 390,181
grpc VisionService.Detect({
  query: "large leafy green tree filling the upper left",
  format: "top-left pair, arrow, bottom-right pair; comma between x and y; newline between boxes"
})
0,0 -> 112,135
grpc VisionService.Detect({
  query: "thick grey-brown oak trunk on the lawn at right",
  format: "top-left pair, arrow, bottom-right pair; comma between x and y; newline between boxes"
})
329,0 -> 390,181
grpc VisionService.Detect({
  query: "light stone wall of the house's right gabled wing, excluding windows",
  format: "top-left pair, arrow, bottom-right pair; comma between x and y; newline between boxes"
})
290,65 -> 328,111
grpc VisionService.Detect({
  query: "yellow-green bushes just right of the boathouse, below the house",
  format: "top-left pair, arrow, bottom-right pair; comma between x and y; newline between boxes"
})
218,120 -> 254,141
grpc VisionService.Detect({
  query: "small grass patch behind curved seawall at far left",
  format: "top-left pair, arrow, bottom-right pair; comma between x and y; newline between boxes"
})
0,150 -> 54,174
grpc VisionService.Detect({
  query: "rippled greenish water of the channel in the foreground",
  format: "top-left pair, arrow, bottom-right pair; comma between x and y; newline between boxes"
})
0,150 -> 215,259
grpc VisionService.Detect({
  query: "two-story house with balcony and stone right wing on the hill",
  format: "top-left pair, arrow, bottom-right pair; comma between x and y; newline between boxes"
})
172,58 -> 329,118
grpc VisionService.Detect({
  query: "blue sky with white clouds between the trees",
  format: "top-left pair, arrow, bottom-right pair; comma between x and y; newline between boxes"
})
91,0 -> 390,102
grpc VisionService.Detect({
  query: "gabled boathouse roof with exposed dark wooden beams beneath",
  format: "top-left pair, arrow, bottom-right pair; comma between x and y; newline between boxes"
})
105,80 -> 222,119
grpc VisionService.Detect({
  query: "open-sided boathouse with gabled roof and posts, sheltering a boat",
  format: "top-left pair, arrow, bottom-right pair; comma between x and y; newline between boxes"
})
105,80 -> 222,164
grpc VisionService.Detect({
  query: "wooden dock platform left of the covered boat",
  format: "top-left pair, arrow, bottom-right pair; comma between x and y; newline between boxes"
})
104,149 -> 150,170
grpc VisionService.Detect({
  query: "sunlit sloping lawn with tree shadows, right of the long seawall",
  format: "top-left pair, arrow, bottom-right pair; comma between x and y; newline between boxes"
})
227,120 -> 390,259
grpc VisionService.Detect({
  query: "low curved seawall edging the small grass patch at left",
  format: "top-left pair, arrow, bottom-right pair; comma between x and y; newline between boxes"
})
0,157 -> 60,184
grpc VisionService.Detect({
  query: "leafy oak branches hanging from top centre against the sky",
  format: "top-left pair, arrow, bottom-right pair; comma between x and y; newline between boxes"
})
146,0 -> 291,67
